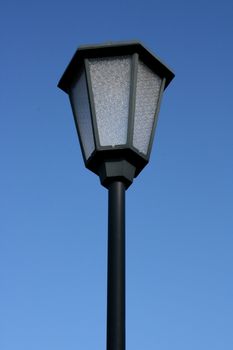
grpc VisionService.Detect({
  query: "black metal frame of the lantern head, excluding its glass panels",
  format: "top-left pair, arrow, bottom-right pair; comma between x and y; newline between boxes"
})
58,41 -> 174,188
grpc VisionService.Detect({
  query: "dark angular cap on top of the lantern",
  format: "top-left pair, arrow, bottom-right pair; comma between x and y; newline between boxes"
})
58,41 -> 175,93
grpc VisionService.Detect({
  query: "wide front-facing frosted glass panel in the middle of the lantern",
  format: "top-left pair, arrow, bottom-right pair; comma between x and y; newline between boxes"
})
89,56 -> 131,146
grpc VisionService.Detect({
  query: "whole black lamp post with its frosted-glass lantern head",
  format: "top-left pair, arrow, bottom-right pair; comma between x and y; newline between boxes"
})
58,42 -> 174,350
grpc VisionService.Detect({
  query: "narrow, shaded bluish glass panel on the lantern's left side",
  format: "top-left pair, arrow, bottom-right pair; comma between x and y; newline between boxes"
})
70,70 -> 95,159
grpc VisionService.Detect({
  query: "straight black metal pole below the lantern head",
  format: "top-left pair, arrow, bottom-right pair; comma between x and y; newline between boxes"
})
107,181 -> 125,350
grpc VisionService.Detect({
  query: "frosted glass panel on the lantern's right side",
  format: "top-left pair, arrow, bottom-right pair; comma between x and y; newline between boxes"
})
133,61 -> 162,155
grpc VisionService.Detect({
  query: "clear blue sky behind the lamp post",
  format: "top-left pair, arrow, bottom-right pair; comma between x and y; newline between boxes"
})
0,0 -> 233,350
